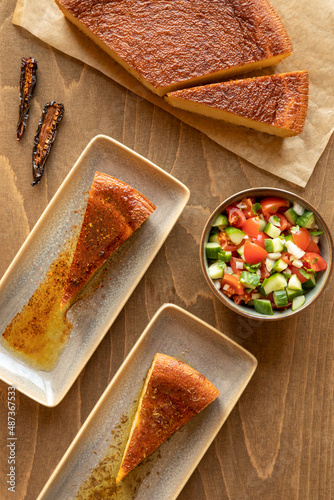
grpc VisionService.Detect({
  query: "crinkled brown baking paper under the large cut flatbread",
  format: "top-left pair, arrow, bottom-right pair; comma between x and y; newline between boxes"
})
13,0 -> 334,187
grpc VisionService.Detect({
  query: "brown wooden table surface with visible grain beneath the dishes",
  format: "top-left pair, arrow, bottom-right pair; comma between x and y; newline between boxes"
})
0,0 -> 334,500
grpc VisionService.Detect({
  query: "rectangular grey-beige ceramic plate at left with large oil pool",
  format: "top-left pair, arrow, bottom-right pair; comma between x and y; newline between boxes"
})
0,136 -> 189,406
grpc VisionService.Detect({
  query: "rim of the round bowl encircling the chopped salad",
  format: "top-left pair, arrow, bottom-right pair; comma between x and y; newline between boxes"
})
200,186 -> 333,321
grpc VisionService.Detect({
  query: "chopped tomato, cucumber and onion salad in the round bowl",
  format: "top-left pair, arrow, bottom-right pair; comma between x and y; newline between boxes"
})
205,197 -> 327,315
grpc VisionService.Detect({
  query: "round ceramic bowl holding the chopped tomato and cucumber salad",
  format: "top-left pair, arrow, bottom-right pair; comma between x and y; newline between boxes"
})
200,187 -> 333,321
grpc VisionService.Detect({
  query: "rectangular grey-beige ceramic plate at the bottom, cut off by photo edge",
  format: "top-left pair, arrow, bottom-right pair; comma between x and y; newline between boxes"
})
38,304 -> 257,500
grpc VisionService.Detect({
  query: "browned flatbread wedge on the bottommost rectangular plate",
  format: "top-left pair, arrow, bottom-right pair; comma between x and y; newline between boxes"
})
116,353 -> 219,483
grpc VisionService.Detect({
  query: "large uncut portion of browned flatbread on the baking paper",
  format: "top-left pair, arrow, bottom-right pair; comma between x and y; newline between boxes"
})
55,0 -> 292,95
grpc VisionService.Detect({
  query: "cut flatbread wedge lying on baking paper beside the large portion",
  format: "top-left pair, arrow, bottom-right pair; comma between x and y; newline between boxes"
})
165,71 -> 308,137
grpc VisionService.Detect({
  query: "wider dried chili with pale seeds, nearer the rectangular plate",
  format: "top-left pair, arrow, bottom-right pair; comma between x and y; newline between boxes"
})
32,101 -> 64,186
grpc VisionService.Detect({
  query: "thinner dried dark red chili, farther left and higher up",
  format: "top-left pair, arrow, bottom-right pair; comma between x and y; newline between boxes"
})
16,57 -> 37,141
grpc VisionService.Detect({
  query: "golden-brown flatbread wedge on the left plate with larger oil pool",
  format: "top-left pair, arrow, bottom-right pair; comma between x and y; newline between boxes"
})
61,172 -> 156,307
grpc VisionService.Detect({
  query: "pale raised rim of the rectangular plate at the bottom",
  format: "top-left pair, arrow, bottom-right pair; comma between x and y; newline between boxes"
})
36,302 -> 258,500
